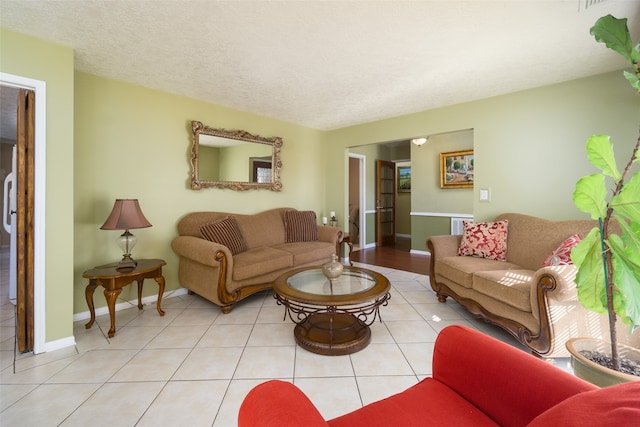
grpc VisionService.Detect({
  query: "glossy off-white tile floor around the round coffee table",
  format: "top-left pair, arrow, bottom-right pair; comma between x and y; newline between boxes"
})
0,264 -> 568,427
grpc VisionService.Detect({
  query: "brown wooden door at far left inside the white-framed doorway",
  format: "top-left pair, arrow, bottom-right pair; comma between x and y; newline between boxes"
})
15,89 -> 35,353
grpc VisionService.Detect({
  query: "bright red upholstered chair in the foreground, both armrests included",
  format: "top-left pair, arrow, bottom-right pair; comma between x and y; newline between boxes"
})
238,325 -> 640,427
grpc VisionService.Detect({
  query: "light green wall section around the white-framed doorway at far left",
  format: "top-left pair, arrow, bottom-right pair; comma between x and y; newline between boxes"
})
0,29 -> 74,342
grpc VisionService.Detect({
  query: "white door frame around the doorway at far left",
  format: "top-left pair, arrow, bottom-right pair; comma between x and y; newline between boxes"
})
0,72 -> 47,354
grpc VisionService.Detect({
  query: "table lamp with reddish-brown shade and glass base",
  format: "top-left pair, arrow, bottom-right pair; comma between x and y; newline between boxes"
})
100,199 -> 151,269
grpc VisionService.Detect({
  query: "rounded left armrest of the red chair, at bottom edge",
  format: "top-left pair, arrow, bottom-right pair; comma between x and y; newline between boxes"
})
238,380 -> 329,427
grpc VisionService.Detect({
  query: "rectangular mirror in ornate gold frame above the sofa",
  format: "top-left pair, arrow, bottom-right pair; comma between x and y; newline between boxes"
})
191,121 -> 282,191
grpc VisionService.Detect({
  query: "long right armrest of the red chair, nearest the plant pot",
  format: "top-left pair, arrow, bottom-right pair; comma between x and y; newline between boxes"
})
433,325 -> 597,425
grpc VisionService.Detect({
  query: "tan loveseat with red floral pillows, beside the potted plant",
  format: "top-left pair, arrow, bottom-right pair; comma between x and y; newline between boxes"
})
427,213 -> 640,357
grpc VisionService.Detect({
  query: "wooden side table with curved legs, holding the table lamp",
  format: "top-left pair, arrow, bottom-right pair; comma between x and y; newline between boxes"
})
82,259 -> 166,338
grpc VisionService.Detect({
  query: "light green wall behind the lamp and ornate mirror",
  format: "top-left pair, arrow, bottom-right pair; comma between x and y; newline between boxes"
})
73,72 -> 328,313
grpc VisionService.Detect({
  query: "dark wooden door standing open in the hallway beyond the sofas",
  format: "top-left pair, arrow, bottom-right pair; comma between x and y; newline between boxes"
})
376,160 -> 396,246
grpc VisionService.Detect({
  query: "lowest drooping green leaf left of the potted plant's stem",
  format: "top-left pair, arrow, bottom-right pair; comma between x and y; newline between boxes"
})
571,228 -> 607,313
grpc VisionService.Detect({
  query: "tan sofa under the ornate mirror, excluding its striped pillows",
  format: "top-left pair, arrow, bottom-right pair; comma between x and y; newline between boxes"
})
171,208 -> 343,313
